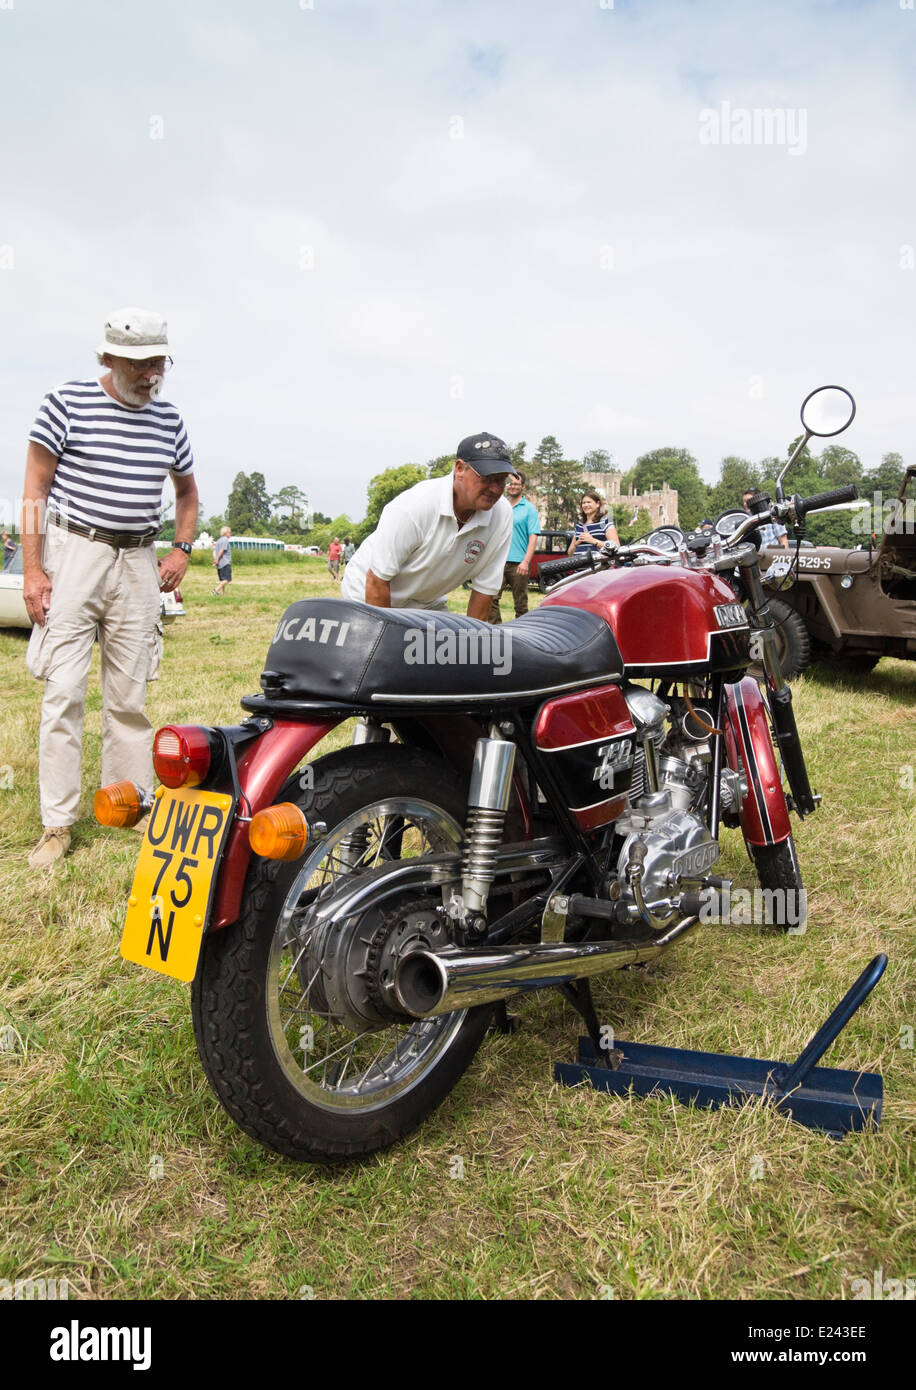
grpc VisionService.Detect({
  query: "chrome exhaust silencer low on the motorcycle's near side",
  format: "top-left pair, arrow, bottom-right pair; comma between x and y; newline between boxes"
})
395,917 -> 699,1019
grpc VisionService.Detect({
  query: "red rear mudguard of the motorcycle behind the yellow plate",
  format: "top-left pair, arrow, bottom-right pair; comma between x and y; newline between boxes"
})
208,719 -> 341,931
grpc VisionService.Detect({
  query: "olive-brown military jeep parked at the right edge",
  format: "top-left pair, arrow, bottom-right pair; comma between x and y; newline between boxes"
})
760,464 -> 916,673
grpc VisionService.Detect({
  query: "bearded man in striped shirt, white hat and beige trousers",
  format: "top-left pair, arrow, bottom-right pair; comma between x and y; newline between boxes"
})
22,309 -> 197,869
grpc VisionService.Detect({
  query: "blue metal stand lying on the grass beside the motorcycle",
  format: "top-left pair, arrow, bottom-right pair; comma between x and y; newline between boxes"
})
553,955 -> 887,1138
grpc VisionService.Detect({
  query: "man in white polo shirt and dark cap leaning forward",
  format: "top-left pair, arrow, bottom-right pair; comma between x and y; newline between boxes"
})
341,431 -> 517,621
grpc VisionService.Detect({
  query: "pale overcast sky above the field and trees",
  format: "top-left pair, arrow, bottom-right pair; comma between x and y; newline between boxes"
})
0,0 -> 916,520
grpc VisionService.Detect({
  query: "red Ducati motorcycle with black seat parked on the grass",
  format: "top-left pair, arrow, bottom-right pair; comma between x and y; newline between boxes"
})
96,388 -> 855,1162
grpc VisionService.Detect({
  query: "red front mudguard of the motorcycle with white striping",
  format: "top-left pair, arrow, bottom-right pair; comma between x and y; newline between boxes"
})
726,676 -> 792,845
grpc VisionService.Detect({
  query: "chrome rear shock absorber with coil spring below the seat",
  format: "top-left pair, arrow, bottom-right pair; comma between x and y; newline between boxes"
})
449,726 -> 516,935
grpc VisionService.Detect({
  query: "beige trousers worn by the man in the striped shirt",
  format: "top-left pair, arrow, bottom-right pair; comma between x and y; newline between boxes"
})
25,525 -> 161,826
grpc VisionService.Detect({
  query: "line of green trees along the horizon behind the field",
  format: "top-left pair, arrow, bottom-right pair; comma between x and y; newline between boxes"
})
175,435 -> 903,550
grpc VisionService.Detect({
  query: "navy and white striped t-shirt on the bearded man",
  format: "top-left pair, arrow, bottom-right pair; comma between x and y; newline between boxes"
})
29,379 -> 193,534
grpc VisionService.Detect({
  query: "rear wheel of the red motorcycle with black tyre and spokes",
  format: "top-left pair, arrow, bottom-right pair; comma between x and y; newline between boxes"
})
192,745 -> 492,1163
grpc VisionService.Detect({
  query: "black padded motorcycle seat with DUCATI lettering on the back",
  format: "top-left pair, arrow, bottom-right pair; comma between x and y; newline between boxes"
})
261,599 -> 623,705
